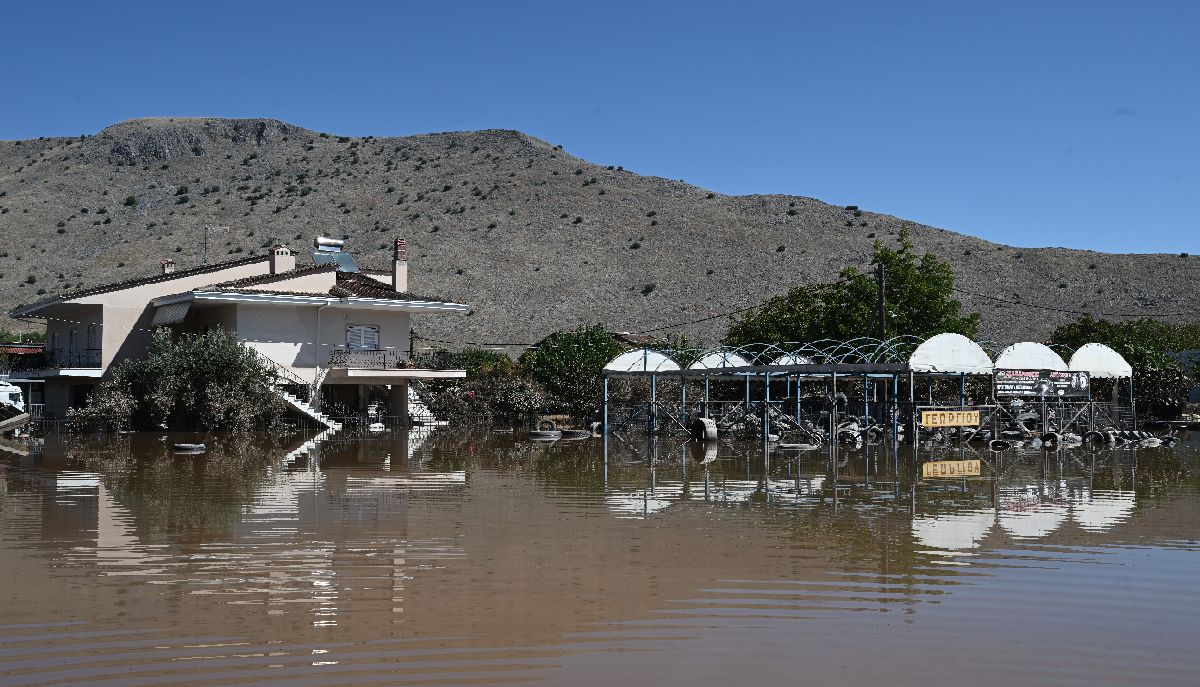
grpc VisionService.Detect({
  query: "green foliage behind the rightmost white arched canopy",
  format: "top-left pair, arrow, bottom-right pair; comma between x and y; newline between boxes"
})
1050,315 -> 1200,417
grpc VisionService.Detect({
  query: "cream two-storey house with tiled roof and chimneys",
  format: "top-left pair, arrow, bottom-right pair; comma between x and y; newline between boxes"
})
12,240 -> 468,417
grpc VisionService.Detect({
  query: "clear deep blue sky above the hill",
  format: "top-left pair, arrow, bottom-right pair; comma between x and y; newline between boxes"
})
0,0 -> 1200,253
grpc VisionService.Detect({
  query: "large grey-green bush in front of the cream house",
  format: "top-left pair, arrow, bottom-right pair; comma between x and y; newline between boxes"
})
70,329 -> 284,430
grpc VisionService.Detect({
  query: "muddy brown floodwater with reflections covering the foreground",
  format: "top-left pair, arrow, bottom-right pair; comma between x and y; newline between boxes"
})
0,429 -> 1200,687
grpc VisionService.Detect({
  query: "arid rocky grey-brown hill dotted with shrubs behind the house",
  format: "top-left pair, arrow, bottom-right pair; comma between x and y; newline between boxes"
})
0,119 -> 1200,344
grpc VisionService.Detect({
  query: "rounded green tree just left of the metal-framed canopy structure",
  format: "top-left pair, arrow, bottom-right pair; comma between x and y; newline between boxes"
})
521,324 -> 620,416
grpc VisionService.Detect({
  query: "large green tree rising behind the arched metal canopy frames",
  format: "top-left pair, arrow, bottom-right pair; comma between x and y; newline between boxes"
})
725,228 -> 979,346
